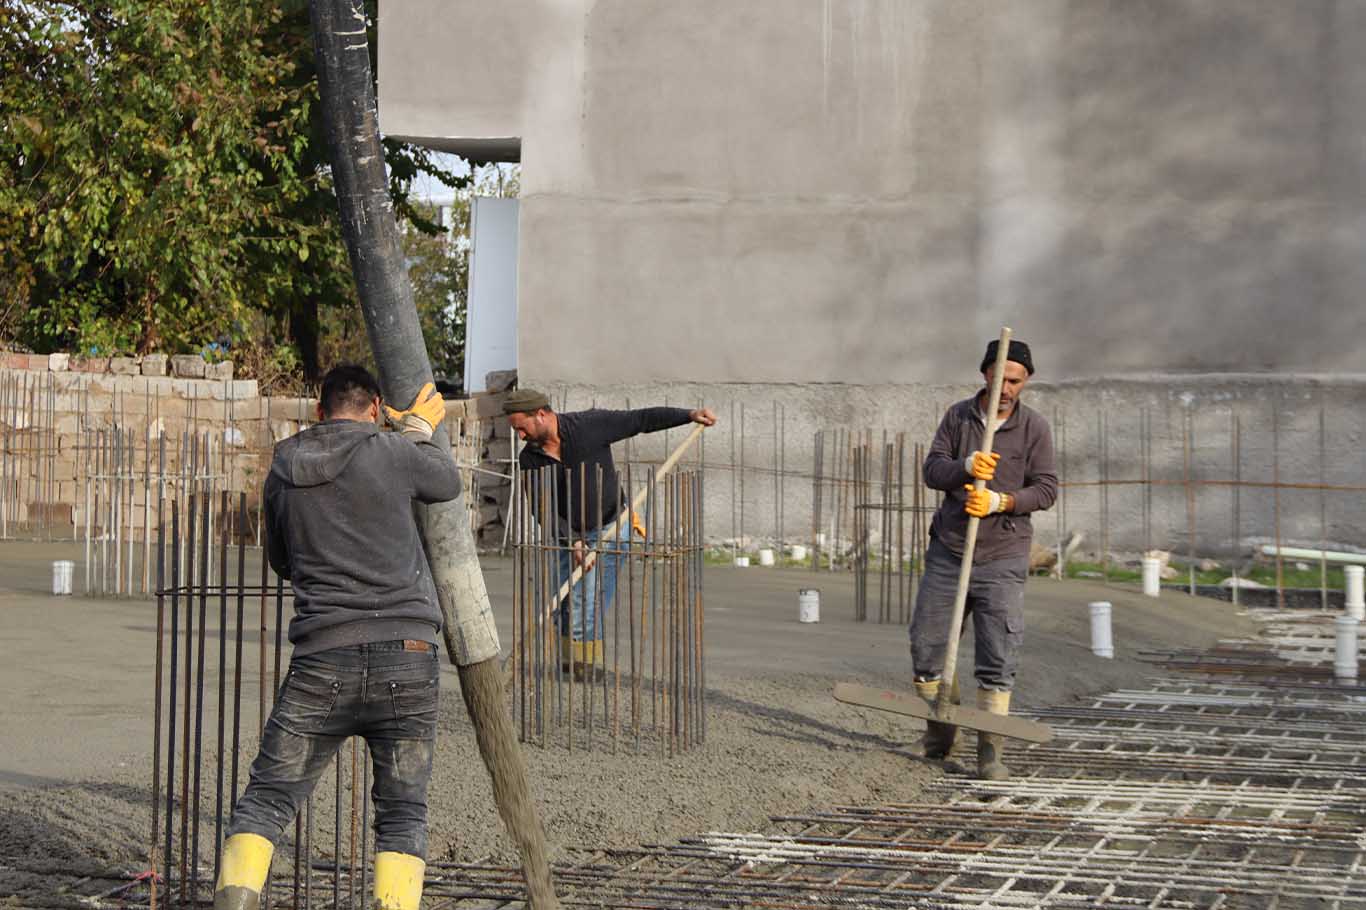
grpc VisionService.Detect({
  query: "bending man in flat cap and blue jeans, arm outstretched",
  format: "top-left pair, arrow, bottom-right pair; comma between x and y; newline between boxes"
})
503,389 -> 716,672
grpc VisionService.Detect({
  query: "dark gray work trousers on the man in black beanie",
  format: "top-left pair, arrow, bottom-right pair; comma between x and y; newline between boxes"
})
911,538 -> 1029,691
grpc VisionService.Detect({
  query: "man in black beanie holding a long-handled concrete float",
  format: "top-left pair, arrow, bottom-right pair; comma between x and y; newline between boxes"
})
910,342 -> 1057,780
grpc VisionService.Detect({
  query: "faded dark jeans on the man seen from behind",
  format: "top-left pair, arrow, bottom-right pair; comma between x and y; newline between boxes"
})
228,641 -> 440,859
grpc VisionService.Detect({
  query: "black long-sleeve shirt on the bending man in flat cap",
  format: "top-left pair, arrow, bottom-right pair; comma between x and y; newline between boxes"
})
518,407 -> 693,538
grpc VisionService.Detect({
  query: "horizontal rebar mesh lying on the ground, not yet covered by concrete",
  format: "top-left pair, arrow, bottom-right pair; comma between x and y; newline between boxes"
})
428,601 -> 1366,910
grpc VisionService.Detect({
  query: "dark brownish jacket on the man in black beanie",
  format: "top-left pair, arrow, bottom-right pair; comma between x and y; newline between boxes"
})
925,395 -> 1057,564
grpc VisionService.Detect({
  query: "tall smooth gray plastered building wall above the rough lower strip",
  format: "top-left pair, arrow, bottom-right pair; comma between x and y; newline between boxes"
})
380,0 -> 1366,387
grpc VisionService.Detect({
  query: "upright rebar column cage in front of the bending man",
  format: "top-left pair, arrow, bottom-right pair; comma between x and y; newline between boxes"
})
511,463 -> 706,756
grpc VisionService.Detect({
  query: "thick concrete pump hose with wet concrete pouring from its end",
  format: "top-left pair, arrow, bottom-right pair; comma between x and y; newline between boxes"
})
309,0 -> 559,910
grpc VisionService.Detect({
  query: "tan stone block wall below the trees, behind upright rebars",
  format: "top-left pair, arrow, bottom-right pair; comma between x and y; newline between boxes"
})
0,353 -> 511,548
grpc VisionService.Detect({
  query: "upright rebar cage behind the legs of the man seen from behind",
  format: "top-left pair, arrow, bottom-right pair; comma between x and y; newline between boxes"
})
148,492 -> 385,907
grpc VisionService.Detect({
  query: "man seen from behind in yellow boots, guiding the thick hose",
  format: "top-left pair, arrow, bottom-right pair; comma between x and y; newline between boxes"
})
213,366 -> 460,910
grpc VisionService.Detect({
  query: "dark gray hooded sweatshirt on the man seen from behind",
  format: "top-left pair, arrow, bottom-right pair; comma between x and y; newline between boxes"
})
265,421 -> 460,654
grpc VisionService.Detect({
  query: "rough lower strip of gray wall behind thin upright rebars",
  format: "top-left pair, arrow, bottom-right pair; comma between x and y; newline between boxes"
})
527,374 -> 1366,557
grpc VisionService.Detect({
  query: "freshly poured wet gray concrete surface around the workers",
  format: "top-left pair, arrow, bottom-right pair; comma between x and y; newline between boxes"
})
0,542 -> 1253,903
